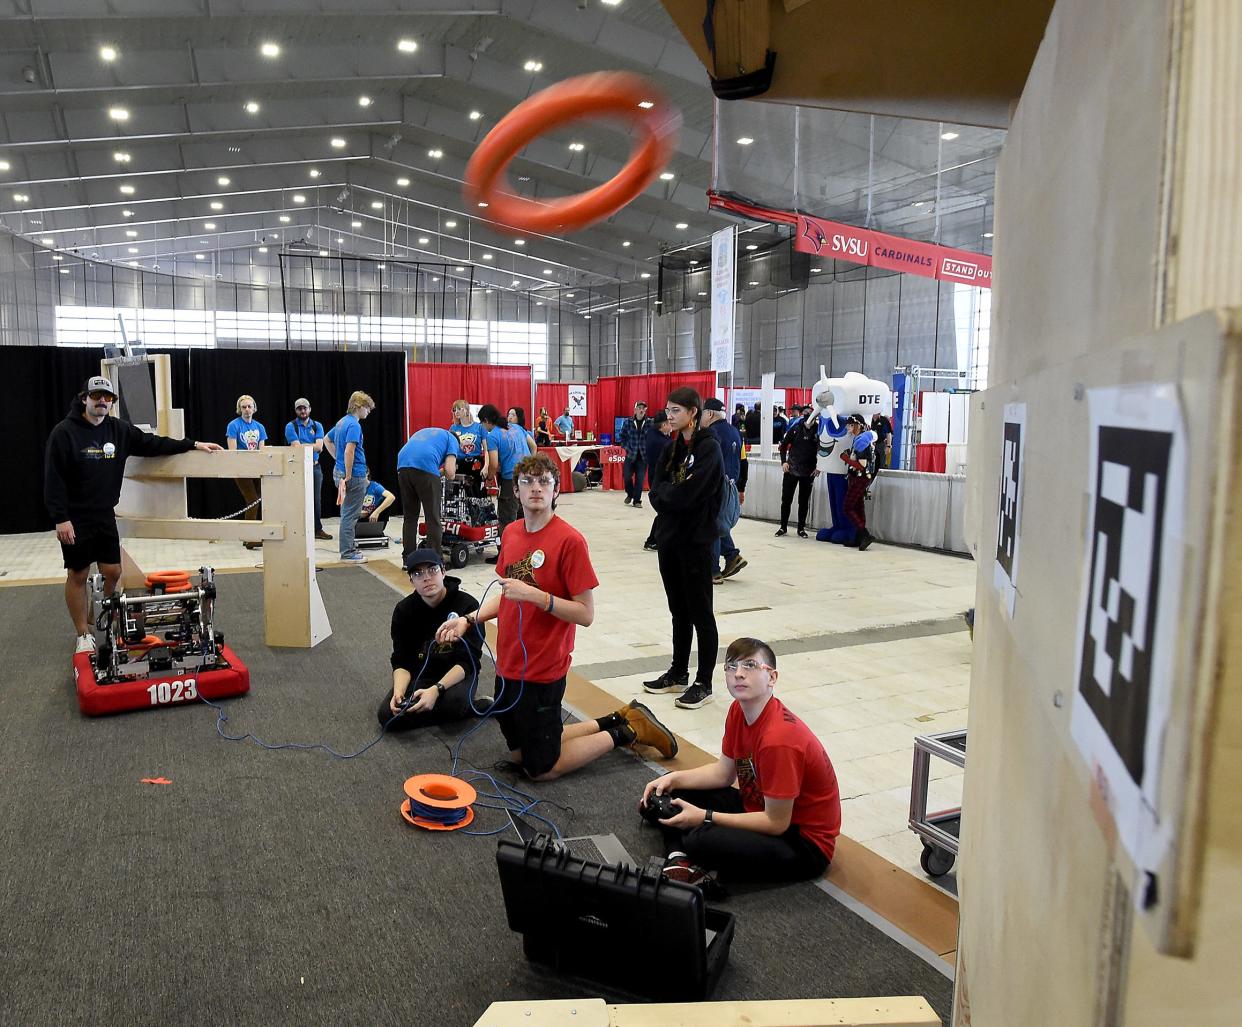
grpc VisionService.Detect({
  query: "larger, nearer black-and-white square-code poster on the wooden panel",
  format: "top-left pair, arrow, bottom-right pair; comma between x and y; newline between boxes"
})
1071,385 -> 1186,869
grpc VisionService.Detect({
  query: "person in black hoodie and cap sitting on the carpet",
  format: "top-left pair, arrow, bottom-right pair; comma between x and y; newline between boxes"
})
378,549 -> 482,731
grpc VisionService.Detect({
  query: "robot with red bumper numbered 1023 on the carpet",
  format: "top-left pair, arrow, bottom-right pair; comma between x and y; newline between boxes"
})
73,568 -> 250,717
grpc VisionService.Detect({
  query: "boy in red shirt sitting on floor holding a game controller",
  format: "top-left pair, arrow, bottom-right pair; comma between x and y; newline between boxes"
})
640,638 -> 841,884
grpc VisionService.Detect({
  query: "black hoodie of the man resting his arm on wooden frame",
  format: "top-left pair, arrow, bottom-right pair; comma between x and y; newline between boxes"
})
43,414 -> 194,530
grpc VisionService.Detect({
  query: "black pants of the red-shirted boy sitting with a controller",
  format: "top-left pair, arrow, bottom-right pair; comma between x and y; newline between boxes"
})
660,789 -> 828,882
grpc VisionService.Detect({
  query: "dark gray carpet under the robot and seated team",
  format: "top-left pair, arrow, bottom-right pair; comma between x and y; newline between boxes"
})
0,569 -> 951,1027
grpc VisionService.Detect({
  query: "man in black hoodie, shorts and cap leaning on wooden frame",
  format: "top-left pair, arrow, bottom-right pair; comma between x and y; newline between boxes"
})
43,375 -> 220,652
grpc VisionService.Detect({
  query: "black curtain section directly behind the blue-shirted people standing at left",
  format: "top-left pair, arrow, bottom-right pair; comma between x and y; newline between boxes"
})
179,349 -> 405,517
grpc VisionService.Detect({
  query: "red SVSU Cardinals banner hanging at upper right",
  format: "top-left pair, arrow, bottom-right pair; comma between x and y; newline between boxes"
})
708,192 -> 992,289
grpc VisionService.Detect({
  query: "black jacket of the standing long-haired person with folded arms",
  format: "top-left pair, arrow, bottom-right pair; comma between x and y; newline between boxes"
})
650,431 -> 724,548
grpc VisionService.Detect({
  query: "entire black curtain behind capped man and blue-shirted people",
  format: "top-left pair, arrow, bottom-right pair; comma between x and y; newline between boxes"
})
9,346 -> 405,535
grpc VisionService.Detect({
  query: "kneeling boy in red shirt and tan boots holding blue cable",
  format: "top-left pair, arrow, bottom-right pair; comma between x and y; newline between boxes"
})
436,453 -> 677,781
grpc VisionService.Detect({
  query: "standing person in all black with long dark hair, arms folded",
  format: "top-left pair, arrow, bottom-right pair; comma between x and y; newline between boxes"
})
642,387 -> 724,709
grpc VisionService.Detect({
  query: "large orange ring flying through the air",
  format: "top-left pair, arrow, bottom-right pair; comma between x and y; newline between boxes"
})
466,71 -> 681,232
